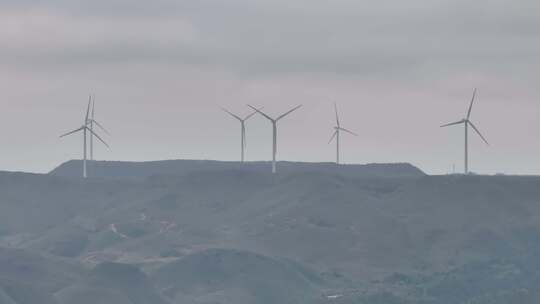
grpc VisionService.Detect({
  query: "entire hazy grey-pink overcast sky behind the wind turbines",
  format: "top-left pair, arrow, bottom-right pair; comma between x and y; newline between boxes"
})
0,0 -> 540,174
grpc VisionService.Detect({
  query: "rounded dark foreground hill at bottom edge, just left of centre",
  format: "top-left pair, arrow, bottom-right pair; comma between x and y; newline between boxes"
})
153,249 -> 322,304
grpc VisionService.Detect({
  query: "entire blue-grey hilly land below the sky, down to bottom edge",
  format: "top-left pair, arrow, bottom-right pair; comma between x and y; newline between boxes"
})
0,161 -> 540,304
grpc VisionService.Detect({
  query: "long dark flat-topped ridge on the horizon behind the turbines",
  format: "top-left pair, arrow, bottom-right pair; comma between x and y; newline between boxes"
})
50,160 -> 425,180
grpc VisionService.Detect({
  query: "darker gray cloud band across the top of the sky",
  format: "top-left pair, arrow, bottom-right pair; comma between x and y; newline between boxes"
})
2,0 -> 540,74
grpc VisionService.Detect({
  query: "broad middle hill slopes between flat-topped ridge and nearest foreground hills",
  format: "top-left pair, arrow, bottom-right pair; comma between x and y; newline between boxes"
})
5,169 -> 540,278
